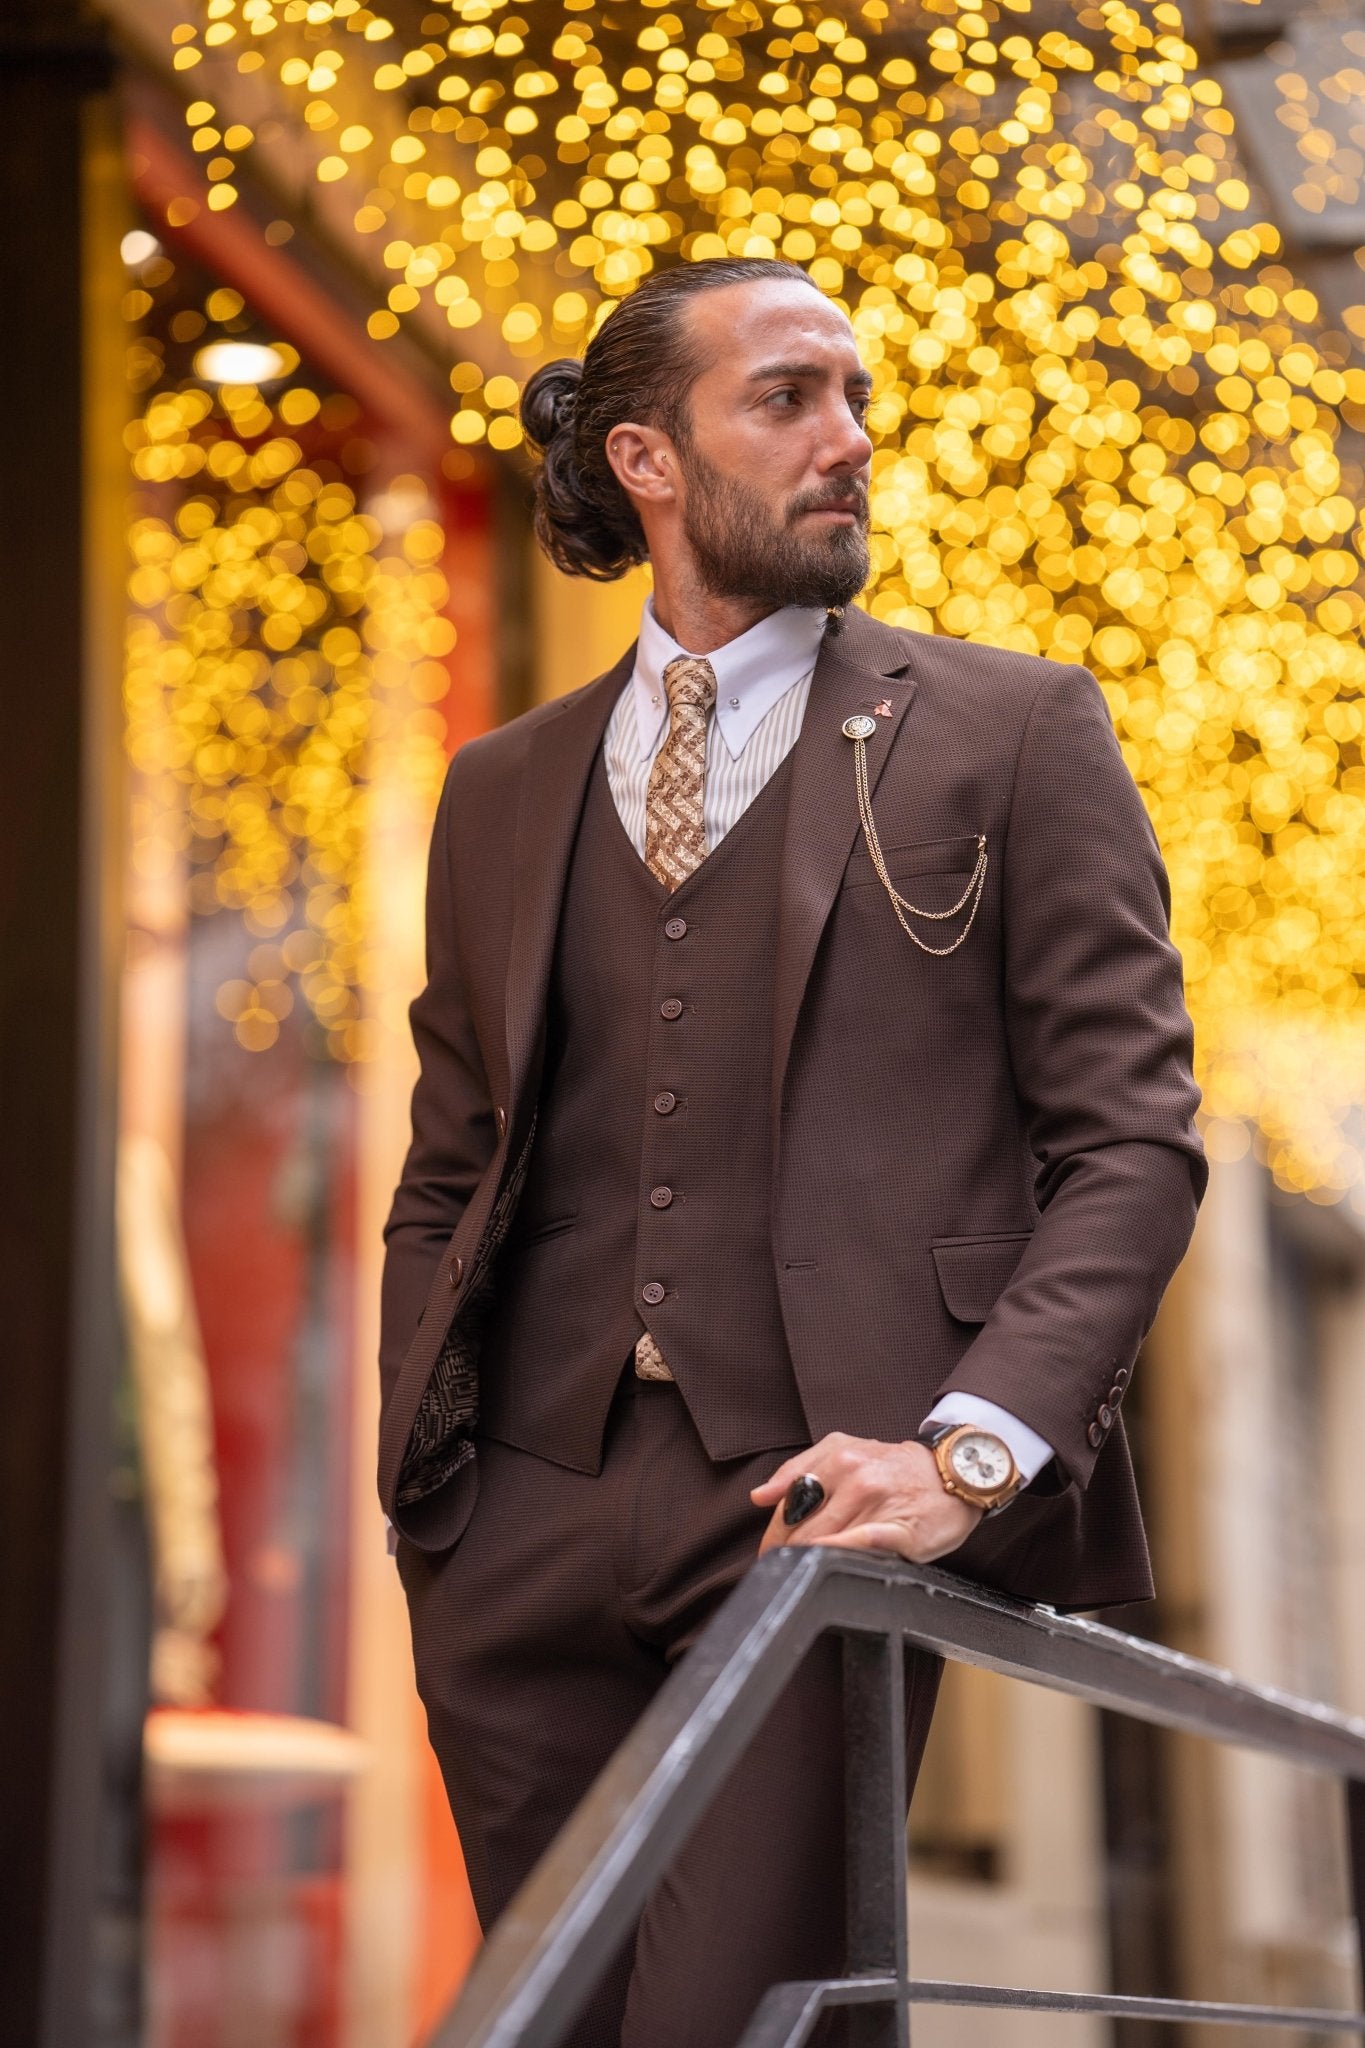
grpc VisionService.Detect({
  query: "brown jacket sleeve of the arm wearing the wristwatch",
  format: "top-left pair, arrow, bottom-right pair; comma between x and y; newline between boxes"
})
939,668 -> 1207,1485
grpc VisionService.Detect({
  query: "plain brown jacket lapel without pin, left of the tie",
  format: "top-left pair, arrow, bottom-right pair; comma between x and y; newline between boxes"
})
505,647 -> 634,1130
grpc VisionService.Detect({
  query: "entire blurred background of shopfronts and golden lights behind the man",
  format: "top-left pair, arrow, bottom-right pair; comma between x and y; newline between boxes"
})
0,0 -> 1365,2048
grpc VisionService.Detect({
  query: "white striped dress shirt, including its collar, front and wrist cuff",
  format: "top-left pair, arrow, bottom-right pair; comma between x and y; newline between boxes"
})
602,598 -> 1052,1481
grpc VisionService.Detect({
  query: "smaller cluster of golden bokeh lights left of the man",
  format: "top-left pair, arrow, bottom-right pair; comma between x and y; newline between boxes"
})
125,260 -> 454,1063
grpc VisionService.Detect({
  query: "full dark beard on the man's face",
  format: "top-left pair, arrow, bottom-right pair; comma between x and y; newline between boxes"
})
679,449 -> 870,610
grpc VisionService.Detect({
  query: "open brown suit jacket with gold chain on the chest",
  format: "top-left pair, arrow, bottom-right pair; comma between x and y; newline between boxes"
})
381,610 -> 1205,1606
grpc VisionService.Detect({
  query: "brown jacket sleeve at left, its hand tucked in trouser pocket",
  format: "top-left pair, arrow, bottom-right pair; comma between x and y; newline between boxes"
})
379,756 -> 497,1403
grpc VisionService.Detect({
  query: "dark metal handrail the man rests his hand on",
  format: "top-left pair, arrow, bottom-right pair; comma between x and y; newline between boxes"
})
428,1544 -> 1365,2048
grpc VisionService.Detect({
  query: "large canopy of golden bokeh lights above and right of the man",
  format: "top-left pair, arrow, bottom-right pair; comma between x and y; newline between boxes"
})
154,0 -> 1365,1200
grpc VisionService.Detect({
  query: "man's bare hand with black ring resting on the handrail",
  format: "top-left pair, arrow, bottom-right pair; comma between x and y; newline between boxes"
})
749,1434 -> 982,1565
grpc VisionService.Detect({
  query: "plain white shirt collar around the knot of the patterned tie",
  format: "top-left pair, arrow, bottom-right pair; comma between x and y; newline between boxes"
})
630,598 -> 827,760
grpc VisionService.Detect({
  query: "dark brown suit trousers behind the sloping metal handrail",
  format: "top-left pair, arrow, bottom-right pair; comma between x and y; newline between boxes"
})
399,1372 -> 945,2048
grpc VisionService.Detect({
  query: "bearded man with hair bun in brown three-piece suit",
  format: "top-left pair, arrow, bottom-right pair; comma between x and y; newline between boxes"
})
381,262 -> 1203,2048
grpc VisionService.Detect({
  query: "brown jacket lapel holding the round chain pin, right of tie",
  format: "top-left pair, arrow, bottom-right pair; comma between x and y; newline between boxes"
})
772,610 -> 915,1155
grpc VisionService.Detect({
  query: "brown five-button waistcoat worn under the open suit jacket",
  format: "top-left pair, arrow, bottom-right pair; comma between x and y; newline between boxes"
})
481,760 -> 806,1470
